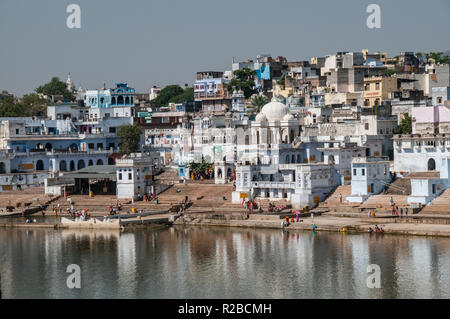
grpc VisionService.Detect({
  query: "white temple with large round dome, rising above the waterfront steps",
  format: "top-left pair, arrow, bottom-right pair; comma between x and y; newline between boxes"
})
215,98 -> 338,208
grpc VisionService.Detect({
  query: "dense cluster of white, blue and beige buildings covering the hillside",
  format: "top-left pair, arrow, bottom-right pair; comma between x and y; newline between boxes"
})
0,50 -> 450,207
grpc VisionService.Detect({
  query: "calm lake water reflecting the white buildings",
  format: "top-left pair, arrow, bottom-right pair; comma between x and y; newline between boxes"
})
0,227 -> 450,298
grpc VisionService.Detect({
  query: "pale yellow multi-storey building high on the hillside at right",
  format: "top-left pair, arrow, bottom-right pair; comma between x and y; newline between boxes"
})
363,76 -> 398,107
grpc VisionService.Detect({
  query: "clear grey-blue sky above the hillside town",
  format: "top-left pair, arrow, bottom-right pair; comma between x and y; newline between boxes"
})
0,0 -> 450,96
